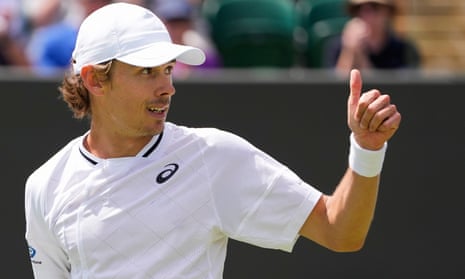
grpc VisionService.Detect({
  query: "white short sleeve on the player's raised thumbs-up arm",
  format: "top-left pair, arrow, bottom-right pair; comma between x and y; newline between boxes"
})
205,131 -> 321,254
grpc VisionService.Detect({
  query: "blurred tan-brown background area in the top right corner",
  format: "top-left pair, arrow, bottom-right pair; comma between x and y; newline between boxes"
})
395,0 -> 465,73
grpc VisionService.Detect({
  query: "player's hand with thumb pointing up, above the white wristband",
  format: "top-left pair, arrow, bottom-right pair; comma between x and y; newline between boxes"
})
347,70 -> 401,150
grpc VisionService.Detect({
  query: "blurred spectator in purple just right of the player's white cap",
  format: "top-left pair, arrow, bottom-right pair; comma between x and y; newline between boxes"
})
148,0 -> 221,77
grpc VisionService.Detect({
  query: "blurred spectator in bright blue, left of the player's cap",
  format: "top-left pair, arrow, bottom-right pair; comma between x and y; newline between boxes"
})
27,0 -> 112,76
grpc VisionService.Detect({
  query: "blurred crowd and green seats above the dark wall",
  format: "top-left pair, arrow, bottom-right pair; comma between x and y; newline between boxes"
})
0,0 -> 421,77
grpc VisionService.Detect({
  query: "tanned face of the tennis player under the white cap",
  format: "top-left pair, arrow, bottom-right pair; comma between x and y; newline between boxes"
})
93,61 -> 175,137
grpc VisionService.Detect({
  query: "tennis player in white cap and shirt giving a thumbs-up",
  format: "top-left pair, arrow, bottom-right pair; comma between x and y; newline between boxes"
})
25,3 -> 401,279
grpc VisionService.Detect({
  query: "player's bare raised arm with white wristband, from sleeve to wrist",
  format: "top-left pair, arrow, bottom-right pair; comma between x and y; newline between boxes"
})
301,135 -> 387,252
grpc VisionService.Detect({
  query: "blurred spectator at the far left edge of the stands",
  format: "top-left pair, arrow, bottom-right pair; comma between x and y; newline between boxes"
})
0,0 -> 29,67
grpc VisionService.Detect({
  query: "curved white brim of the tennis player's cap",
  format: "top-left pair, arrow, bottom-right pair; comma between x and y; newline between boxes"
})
115,42 -> 205,67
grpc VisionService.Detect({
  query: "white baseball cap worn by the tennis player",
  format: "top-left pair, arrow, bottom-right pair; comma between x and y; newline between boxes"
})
73,3 -> 205,74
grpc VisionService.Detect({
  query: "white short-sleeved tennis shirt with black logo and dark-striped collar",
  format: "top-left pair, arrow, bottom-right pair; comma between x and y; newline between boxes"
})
25,123 -> 321,279
